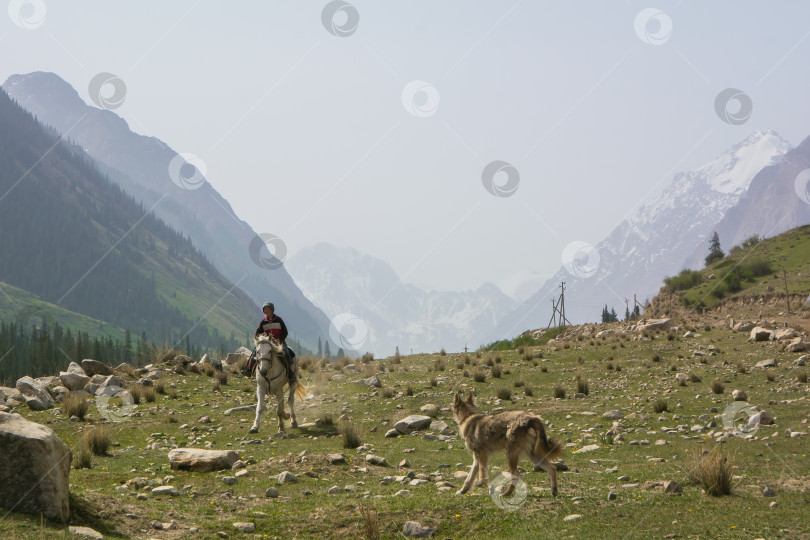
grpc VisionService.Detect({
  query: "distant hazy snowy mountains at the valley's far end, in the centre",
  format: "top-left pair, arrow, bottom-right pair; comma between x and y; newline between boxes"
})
285,243 -> 516,355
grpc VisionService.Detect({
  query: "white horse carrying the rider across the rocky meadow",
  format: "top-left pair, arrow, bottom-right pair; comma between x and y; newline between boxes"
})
248,336 -> 307,433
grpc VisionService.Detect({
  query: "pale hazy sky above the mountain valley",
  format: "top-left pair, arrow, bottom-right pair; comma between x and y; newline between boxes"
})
0,0 -> 810,300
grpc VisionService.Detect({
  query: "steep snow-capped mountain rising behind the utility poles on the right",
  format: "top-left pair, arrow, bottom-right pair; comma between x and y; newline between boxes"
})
487,130 -> 790,341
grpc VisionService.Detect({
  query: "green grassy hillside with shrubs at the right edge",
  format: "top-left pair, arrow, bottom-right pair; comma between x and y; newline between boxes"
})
662,225 -> 810,309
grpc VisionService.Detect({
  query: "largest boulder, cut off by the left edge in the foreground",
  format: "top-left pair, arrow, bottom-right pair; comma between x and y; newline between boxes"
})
0,413 -> 73,521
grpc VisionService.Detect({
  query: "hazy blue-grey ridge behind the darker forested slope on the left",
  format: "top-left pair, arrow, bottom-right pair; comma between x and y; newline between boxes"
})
3,72 -> 329,346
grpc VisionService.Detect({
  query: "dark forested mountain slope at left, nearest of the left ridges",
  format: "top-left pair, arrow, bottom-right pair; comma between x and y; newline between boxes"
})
0,87 -> 255,347
